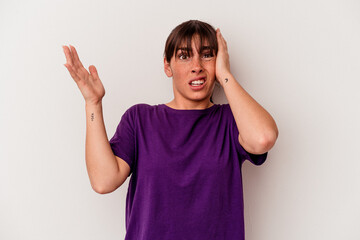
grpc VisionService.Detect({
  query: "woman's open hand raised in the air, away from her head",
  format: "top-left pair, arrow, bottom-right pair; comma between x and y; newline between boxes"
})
63,45 -> 105,104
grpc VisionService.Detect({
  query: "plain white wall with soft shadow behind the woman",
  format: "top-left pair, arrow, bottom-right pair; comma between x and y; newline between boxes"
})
0,0 -> 360,240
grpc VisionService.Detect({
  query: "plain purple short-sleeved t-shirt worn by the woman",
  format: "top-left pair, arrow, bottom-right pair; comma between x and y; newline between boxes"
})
110,104 -> 267,240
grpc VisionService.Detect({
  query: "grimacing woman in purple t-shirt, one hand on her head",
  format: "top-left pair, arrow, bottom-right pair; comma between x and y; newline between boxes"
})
64,20 -> 278,240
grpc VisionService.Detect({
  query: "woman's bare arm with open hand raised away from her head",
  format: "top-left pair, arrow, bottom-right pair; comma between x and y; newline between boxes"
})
63,46 -> 130,194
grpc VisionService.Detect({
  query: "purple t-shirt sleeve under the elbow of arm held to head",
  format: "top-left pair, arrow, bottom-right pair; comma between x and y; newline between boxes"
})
229,106 -> 268,165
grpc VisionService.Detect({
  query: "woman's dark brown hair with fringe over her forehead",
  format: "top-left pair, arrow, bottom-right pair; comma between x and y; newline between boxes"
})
164,20 -> 218,63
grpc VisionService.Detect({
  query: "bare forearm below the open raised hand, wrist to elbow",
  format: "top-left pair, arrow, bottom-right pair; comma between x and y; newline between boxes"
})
85,102 -> 120,193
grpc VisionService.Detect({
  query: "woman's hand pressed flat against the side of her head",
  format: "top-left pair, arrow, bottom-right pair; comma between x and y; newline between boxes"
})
215,28 -> 231,86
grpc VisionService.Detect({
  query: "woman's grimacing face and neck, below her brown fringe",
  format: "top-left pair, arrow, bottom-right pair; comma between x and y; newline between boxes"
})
164,35 -> 216,106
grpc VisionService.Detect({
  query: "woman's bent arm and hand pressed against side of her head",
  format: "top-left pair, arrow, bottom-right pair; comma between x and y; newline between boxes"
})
216,29 -> 278,154
